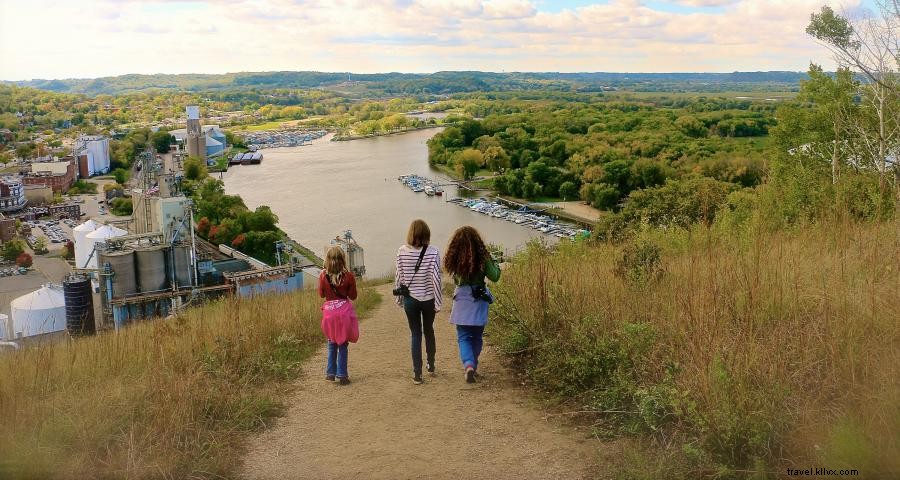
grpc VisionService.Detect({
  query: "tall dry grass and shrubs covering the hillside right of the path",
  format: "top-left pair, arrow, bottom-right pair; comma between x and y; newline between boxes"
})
490,220 -> 900,478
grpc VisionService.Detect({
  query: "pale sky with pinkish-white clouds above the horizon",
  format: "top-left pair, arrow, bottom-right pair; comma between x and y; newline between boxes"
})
0,0 -> 870,80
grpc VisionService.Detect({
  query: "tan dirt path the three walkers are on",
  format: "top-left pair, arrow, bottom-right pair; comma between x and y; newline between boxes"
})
243,286 -> 609,480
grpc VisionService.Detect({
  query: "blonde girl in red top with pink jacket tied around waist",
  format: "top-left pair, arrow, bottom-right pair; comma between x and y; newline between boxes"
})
319,246 -> 359,385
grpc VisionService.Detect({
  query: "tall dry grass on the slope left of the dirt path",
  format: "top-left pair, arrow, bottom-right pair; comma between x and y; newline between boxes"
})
0,290 -> 380,479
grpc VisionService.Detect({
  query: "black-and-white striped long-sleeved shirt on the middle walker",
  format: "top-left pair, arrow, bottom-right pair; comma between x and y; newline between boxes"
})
394,245 -> 444,310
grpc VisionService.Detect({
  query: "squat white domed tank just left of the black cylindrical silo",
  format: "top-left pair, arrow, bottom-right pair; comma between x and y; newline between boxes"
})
10,285 -> 66,338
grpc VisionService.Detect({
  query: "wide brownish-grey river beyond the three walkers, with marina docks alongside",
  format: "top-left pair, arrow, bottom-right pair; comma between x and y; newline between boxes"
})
222,129 -> 556,277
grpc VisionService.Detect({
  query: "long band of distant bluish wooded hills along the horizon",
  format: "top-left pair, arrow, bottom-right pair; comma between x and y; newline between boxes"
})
7,71 -> 806,95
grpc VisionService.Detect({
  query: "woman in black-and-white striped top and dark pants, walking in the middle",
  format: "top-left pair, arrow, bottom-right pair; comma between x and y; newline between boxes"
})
394,220 -> 442,385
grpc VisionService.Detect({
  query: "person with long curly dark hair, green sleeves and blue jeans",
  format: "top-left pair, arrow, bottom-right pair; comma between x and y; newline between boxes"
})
444,226 -> 500,383
